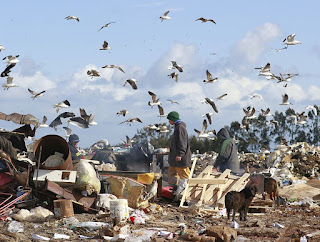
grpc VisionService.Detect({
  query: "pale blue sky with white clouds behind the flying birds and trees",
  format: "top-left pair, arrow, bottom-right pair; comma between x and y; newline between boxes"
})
0,0 -> 320,148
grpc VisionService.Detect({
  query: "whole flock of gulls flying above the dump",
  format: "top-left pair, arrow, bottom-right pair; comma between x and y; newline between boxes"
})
0,11 -> 317,146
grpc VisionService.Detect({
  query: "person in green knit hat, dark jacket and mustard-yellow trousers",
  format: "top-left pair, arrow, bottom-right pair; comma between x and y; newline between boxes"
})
167,111 -> 191,201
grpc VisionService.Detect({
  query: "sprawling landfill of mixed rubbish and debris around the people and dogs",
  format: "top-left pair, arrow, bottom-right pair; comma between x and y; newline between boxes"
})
0,133 -> 320,241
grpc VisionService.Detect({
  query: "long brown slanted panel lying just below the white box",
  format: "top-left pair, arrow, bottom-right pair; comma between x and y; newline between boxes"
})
44,180 -> 97,212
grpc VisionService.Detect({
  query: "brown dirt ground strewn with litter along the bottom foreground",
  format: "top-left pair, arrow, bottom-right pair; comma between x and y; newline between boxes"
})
0,193 -> 320,241
